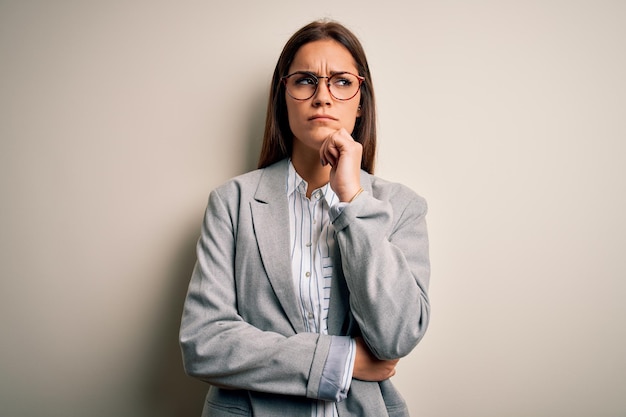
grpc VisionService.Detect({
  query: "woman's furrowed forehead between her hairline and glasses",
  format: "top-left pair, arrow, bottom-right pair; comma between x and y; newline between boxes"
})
290,39 -> 357,72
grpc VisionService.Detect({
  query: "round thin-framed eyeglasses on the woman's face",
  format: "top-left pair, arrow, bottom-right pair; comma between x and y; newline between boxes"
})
281,71 -> 365,101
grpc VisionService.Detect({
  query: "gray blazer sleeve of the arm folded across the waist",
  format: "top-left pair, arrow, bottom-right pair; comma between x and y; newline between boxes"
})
180,186 -> 332,399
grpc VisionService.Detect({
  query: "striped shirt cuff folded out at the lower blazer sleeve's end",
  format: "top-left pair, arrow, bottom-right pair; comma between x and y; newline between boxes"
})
319,336 -> 356,402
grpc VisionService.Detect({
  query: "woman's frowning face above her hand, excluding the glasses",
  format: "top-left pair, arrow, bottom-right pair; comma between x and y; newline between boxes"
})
285,40 -> 361,152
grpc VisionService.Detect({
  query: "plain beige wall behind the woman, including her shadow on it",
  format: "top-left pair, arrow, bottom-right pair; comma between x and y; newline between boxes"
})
0,0 -> 626,417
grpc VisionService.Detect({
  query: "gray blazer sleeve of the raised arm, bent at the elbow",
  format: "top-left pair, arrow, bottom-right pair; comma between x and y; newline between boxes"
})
333,183 -> 430,359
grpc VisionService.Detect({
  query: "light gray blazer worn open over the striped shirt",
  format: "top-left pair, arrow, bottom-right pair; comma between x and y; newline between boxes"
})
180,160 -> 430,417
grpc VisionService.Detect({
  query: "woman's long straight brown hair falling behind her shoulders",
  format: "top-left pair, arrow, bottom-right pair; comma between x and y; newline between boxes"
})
258,21 -> 376,174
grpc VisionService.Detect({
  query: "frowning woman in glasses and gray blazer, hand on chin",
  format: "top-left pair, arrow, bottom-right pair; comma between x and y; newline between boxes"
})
180,22 -> 430,417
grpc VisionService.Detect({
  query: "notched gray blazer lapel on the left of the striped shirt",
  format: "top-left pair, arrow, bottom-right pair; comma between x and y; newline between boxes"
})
250,159 -> 305,333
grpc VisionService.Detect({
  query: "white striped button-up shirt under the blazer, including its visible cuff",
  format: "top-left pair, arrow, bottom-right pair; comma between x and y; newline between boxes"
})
287,161 -> 355,417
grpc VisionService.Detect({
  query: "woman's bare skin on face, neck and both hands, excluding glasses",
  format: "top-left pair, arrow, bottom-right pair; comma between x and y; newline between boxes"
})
285,40 -> 398,381
